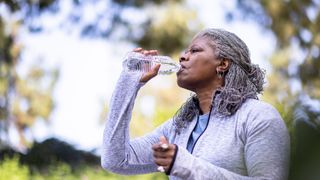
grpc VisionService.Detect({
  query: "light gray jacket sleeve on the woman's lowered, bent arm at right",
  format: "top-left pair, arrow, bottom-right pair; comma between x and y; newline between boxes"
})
170,103 -> 290,180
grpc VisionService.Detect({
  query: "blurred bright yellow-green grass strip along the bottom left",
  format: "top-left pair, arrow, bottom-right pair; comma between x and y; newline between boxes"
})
0,156 -> 168,180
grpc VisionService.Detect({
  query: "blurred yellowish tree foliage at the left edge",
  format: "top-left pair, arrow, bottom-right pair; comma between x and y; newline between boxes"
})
0,15 -> 58,147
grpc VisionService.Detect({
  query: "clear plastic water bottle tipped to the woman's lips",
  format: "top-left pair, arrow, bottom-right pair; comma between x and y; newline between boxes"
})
122,52 -> 181,74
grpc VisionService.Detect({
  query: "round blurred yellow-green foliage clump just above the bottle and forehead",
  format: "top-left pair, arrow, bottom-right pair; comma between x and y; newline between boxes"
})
134,3 -> 201,55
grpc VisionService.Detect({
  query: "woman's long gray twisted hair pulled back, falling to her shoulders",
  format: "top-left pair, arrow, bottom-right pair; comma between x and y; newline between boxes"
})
173,29 -> 265,132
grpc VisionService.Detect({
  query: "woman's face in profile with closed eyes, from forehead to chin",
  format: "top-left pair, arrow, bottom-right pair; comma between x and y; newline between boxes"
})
177,37 -> 220,91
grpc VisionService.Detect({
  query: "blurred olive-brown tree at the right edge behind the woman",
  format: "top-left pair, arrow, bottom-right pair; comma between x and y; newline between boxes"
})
229,0 -> 320,122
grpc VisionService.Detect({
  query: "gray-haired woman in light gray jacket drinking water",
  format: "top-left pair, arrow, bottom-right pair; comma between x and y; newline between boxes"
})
101,29 -> 290,180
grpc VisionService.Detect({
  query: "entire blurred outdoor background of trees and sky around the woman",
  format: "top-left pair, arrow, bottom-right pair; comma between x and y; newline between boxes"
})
0,0 -> 320,180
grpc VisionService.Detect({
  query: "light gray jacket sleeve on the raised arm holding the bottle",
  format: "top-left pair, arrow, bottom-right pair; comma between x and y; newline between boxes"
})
101,72 -> 174,174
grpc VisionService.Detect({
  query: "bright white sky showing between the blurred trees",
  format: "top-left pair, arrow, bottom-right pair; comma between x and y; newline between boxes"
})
11,0 -> 275,151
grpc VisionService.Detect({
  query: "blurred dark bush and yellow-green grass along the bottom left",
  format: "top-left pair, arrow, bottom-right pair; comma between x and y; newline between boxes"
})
0,138 -> 167,180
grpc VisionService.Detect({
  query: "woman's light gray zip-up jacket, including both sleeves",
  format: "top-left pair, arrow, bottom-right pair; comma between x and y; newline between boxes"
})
101,72 -> 290,180
